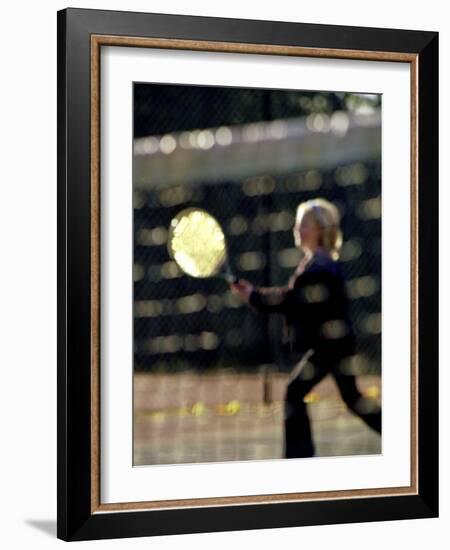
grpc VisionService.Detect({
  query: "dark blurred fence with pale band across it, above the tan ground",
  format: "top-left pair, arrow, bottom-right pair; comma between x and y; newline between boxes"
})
133,84 -> 381,380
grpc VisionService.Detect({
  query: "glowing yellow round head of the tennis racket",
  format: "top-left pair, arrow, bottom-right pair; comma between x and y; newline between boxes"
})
168,208 -> 226,277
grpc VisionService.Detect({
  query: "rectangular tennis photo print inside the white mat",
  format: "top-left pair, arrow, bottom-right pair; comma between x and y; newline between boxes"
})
133,82 -> 382,466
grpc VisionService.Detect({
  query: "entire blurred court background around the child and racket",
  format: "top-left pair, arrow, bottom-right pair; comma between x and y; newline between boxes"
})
133,84 -> 381,465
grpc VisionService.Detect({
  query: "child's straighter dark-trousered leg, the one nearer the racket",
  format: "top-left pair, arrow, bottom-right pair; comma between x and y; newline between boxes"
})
284,355 -> 329,458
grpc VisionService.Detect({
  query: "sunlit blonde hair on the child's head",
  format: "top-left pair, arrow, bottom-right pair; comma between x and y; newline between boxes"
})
296,198 -> 343,260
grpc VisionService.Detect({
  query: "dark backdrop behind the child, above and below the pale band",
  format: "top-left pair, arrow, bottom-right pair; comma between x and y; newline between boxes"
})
133,84 -> 381,378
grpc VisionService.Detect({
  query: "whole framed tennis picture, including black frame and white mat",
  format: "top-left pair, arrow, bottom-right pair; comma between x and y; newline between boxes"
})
58,9 -> 438,540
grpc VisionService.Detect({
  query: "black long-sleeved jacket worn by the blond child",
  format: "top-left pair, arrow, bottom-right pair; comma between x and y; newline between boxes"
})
249,250 -> 355,360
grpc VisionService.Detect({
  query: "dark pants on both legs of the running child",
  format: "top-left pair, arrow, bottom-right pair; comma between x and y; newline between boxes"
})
284,352 -> 381,458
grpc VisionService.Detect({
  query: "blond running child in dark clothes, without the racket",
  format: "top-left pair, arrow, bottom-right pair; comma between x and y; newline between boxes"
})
231,199 -> 381,458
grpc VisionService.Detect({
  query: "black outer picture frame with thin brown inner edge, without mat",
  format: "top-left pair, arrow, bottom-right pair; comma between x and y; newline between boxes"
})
57,9 -> 438,541
